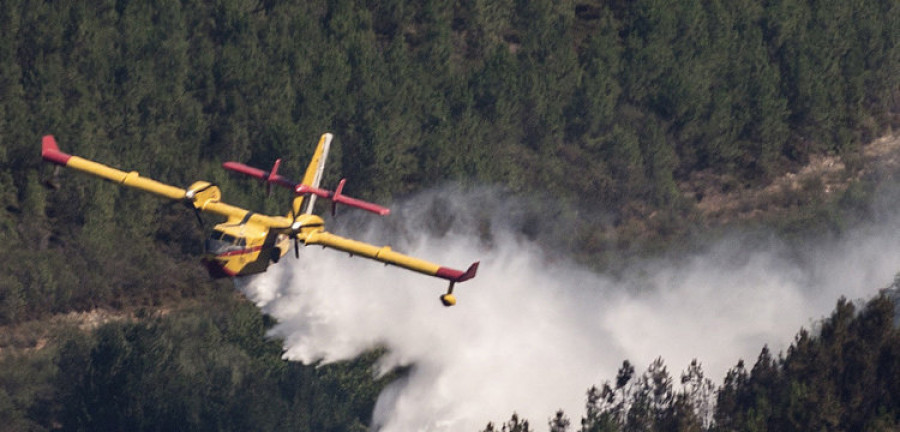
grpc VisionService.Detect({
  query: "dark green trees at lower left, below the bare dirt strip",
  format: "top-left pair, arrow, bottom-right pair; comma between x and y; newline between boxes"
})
0,295 -> 386,431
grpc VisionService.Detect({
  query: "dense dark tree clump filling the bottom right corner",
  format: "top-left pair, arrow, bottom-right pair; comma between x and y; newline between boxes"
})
715,293 -> 900,430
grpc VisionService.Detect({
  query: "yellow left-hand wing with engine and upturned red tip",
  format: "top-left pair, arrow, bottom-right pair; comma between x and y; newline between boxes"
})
41,135 -> 292,229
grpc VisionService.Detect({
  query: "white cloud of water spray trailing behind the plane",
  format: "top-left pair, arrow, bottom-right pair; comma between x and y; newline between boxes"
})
241,187 -> 900,431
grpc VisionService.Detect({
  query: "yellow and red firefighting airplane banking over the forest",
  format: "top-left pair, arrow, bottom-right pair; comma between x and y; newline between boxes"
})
41,133 -> 478,306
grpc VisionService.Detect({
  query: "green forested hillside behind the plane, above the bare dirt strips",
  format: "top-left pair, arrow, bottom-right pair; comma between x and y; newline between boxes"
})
0,0 -> 900,322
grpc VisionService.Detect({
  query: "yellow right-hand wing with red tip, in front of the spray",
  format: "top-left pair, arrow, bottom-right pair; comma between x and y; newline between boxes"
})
298,231 -> 478,283
